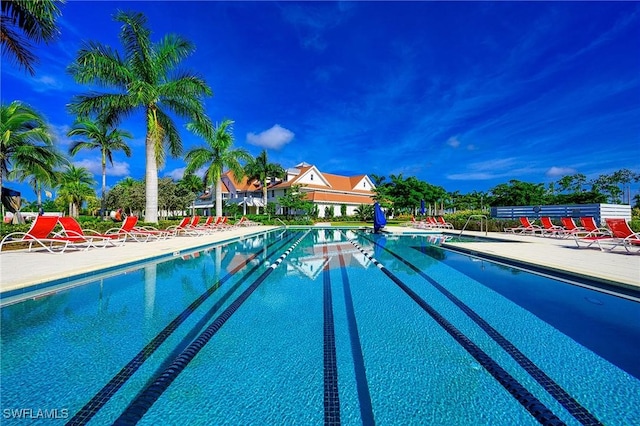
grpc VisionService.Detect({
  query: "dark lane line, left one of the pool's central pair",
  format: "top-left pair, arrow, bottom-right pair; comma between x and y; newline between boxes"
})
322,244 -> 340,426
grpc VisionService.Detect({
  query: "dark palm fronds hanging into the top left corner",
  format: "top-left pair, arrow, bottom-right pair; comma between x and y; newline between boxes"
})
0,0 -> 62,75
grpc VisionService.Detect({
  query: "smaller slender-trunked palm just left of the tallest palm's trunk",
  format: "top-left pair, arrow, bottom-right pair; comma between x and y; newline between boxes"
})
67,119 -> 133,216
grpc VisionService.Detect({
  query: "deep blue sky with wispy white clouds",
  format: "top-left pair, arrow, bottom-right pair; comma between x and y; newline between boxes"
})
0,0 -> 640,199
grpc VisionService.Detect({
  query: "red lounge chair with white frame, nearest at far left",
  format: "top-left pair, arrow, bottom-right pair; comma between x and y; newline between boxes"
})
0,216 -> 91,253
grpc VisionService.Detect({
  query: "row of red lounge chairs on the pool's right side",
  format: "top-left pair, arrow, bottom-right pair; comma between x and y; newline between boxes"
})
504,216 -> 640,253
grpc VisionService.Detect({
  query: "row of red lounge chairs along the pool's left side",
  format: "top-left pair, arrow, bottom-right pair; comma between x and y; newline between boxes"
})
0,216 -> 259,253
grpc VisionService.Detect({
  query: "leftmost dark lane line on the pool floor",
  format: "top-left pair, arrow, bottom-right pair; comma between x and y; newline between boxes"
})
67,236 -> 293,425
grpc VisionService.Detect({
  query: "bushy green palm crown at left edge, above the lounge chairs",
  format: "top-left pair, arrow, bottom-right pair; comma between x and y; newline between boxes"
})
0,101 -> 63,199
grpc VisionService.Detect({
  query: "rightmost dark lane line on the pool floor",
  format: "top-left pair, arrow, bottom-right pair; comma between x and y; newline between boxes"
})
396,240 -> 602,426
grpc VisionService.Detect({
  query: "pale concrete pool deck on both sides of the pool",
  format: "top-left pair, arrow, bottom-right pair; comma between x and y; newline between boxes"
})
0,226 -> 640,293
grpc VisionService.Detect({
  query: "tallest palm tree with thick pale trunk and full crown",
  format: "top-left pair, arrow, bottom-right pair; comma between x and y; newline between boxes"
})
69,11 -> 213,223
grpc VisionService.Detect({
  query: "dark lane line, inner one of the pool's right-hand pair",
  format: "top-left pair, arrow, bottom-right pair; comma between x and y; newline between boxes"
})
349,240 -> 565,425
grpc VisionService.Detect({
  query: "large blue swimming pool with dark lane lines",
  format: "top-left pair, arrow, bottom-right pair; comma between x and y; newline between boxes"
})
0,229 -> 640,425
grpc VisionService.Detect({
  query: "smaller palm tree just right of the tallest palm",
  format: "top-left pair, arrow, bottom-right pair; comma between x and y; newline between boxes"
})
184,120 -> 251,220
